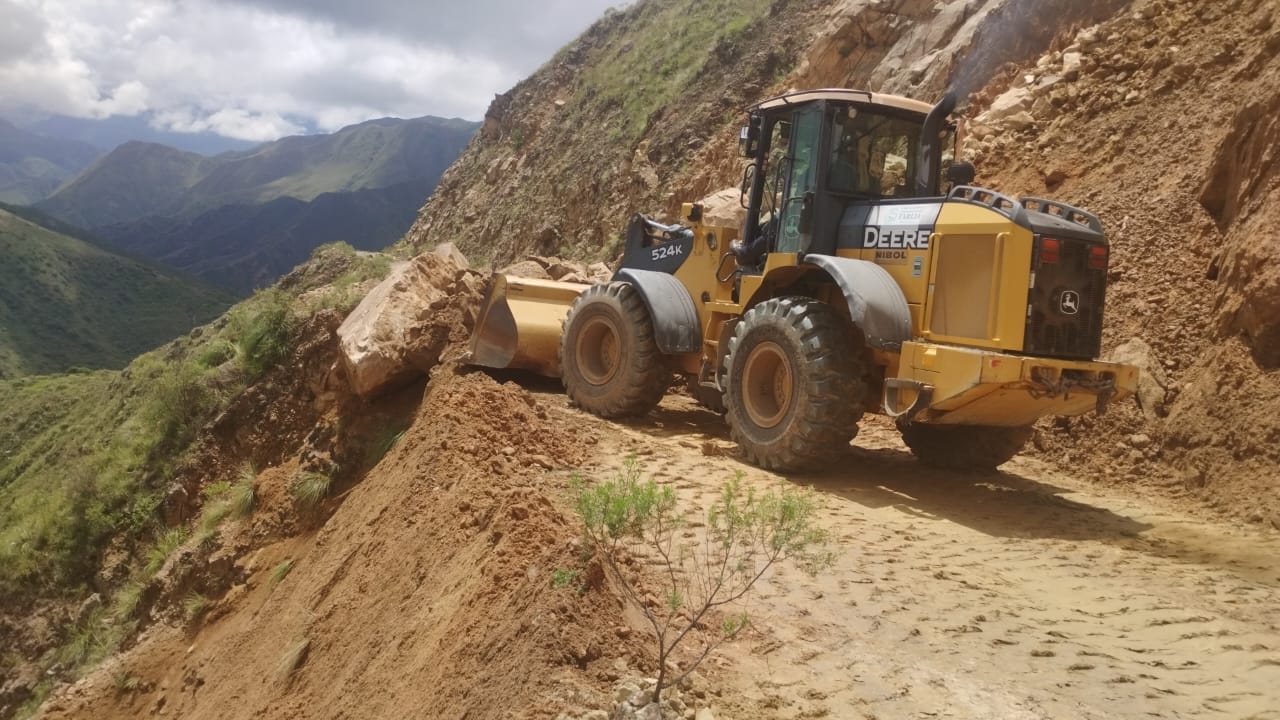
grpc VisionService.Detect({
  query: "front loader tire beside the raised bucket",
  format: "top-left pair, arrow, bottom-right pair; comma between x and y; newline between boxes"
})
559,282 -> 671,418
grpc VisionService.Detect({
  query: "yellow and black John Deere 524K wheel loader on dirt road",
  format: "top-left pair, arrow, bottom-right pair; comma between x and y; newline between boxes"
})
470,90 -> 1138,470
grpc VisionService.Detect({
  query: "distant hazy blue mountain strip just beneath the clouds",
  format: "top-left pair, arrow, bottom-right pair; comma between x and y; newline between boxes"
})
14,114 -> 257,155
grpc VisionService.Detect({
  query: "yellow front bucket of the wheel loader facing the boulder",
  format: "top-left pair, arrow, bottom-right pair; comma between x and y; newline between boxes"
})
468,275 -> 590,378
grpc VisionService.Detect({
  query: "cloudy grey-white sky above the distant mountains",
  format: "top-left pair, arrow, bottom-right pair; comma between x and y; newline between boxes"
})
0,0 -> 626,141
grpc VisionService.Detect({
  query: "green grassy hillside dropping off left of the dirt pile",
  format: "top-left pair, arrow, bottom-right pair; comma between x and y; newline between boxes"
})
0,246 -> 390,716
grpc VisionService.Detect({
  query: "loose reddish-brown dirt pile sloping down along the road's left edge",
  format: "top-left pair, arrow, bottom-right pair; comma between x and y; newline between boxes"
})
45,369 -> 640,719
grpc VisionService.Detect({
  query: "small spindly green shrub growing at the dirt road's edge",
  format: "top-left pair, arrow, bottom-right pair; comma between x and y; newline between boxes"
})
576,457 -> 832,702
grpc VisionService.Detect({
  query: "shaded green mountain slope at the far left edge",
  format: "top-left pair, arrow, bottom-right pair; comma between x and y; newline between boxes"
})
0,206 -> 232,378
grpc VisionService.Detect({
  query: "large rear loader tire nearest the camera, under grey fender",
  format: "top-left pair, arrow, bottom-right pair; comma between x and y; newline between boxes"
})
724,297 -> 865,471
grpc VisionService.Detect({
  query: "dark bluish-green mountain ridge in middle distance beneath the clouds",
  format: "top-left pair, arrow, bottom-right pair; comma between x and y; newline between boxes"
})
37,117 -> 479,292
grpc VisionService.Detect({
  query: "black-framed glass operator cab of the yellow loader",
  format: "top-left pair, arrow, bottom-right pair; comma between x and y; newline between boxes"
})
741,90 -> 956,255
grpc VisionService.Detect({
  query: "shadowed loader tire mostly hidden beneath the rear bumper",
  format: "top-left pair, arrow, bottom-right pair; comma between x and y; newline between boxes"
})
897,421 -> 1034,470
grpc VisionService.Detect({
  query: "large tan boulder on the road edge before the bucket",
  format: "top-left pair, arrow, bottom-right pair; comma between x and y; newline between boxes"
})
338,251 -> 483,398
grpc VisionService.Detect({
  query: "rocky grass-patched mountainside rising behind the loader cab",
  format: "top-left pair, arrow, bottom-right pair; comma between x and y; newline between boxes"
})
407,0 -> 1124,264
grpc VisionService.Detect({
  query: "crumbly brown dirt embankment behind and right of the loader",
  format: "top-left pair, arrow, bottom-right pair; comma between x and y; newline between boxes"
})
974,0 -> 1280,524
